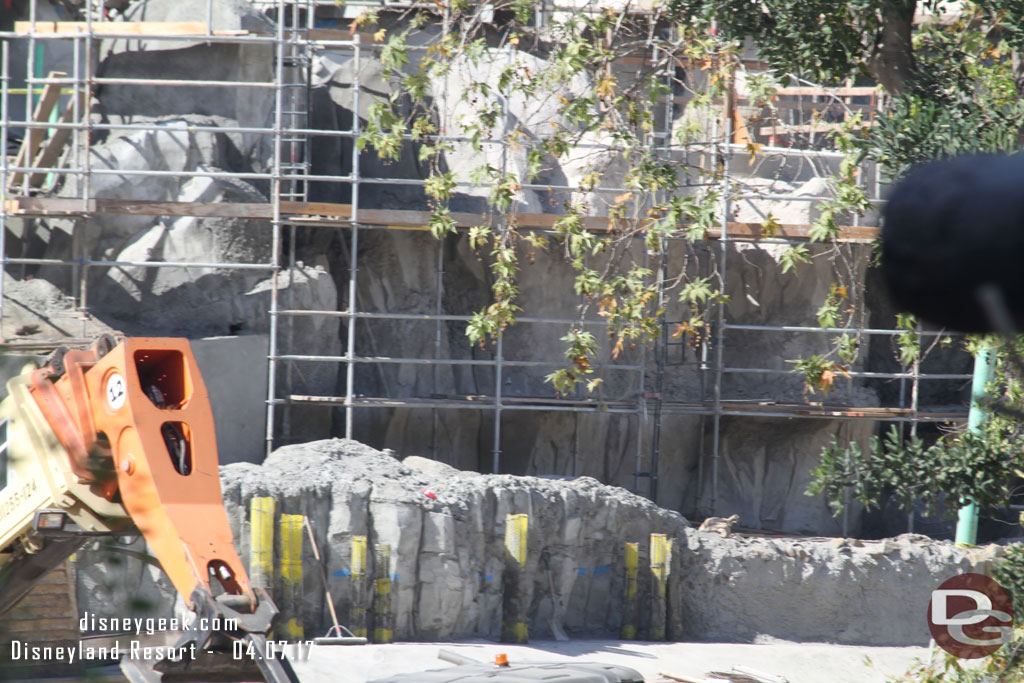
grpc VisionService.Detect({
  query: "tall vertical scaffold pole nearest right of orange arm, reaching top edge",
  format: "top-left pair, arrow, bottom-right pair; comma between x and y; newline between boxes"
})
266,0 -> 285,456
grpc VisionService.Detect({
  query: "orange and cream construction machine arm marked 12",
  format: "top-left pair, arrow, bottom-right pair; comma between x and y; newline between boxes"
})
0,335 -> 296,683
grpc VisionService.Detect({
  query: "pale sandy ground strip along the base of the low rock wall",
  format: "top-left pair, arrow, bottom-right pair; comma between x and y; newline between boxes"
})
293,640 -> 928,683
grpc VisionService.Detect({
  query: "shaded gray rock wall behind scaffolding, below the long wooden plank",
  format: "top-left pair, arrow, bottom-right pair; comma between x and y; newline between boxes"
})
348,225 -> 878,535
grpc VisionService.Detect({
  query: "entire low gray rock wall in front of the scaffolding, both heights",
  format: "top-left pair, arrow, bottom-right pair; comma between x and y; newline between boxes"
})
78,439 -> 987,645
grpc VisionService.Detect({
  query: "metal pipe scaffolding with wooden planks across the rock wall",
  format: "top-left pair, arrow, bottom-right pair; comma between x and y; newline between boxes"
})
0,0 -> 971,532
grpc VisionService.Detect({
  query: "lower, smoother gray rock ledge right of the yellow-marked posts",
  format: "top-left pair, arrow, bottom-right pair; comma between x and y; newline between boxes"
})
681,530 -> 1001,645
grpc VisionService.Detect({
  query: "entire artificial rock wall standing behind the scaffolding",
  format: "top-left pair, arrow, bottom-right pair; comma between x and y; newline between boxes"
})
6,0 -> 966,535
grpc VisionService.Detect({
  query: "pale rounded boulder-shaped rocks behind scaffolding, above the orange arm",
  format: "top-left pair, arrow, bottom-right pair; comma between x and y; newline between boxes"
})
28,117 -> 338,348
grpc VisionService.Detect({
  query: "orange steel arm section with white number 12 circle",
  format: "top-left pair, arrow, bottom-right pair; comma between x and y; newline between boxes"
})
32,338 -> 258,608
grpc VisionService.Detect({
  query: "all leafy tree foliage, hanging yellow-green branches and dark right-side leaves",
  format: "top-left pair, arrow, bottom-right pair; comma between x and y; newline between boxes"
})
354,0 -> 1024,680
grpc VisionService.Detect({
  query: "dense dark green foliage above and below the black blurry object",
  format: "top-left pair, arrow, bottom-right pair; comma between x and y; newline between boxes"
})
790,0 -> 1024,528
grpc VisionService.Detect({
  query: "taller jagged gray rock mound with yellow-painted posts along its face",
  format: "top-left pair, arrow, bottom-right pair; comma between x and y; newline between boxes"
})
221,439 -> 686,640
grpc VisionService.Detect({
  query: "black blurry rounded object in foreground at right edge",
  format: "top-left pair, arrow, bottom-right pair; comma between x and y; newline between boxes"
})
882,155 -> 1024,332
